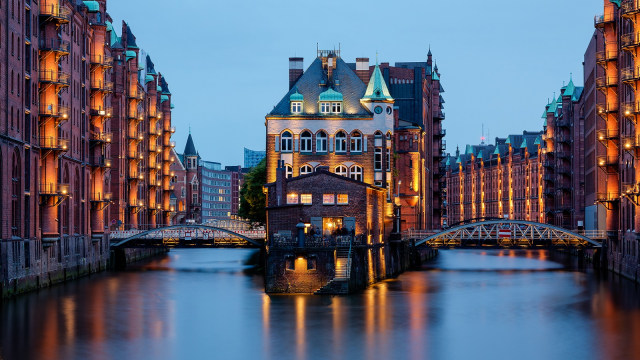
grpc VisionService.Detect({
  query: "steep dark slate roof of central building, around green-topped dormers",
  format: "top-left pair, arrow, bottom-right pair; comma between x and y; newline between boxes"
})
267,58 -> 371,117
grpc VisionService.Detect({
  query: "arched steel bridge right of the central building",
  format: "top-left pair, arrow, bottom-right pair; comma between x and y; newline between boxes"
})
415,220 -> 604,248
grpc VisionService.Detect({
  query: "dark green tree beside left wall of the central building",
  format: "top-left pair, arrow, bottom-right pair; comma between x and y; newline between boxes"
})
238,158 -> 267,224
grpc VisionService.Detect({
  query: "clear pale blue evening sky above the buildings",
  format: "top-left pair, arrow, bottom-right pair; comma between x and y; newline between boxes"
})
107,0 -> 603,165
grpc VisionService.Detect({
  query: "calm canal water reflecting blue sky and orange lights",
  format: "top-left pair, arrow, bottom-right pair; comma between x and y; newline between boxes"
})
0,249 -> 640,359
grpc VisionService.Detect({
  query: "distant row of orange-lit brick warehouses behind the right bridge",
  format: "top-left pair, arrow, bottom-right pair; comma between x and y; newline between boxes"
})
443,131 -> 545,226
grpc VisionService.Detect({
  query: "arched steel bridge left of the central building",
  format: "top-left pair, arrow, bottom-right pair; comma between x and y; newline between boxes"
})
110,224 -> 265,248
